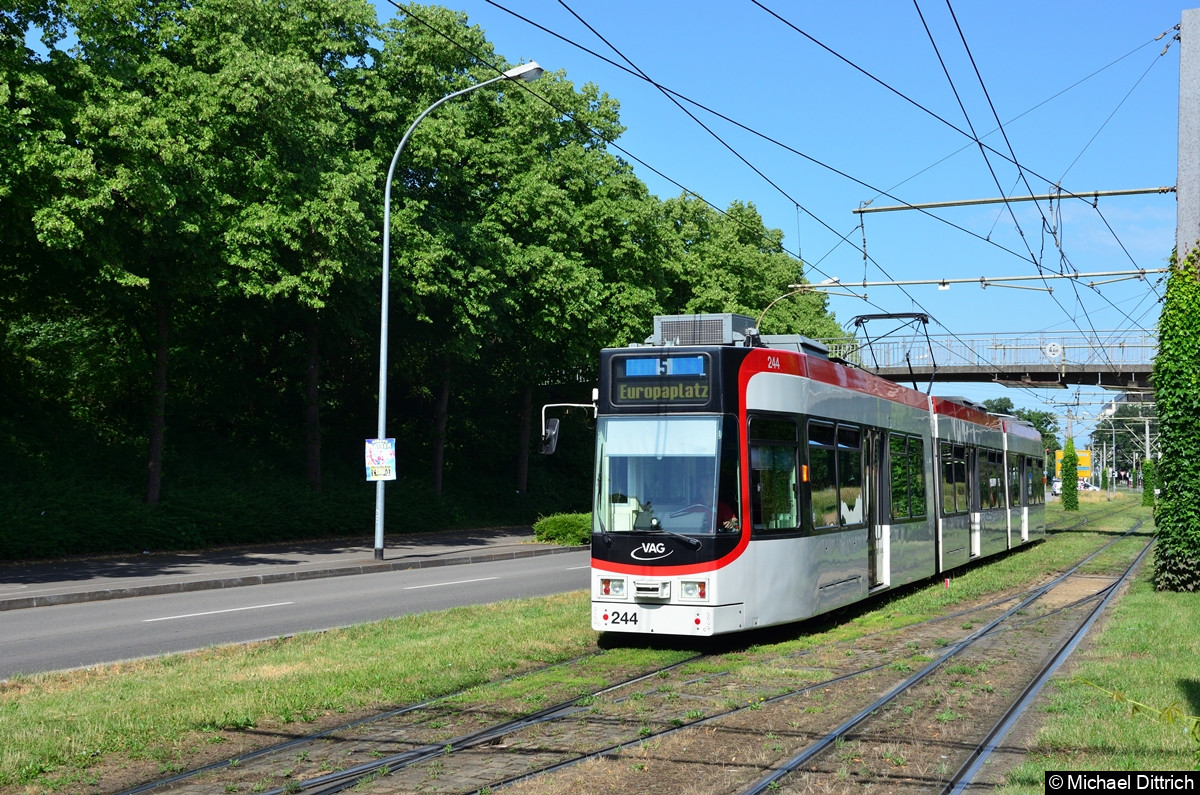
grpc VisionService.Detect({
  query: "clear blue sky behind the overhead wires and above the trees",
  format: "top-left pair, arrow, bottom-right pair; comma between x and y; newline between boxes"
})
377,0 -> 1186,442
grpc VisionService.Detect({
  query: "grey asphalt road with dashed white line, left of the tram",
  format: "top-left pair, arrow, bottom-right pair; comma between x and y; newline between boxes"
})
0,549 -> 589,679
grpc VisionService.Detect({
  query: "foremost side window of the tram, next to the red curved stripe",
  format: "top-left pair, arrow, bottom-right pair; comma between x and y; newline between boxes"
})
750,417 -> 800,533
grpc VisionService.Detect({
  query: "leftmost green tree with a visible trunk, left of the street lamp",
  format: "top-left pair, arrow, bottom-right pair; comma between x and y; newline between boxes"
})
32,0 -> 234,503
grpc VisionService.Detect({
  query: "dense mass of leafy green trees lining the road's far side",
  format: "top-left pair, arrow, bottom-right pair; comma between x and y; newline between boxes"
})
0,0 -> 841,552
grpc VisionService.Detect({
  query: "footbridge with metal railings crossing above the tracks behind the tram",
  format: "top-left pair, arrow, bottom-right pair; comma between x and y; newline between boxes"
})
818,329 -> 1158,391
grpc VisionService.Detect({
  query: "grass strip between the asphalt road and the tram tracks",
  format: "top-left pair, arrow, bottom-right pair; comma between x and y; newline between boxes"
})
0,591 -> 595,793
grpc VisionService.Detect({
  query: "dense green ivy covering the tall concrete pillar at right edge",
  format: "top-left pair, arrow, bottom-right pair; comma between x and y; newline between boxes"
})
1153,247 -> 1200,591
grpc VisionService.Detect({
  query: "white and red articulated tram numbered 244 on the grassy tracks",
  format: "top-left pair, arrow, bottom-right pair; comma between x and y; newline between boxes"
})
592,315 -> 1045,635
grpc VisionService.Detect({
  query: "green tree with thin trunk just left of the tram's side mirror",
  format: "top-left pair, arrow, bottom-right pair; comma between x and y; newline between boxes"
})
475,74 -> 665,499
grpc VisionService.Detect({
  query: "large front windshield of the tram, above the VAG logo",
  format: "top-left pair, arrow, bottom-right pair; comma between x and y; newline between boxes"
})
594,417 -> 738,534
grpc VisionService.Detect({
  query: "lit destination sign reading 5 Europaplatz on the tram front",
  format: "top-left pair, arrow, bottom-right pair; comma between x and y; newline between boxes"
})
612,353 -> 713,406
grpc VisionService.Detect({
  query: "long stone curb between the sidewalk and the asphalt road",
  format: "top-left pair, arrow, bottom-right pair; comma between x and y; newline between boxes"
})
0,546 -> 587,611
